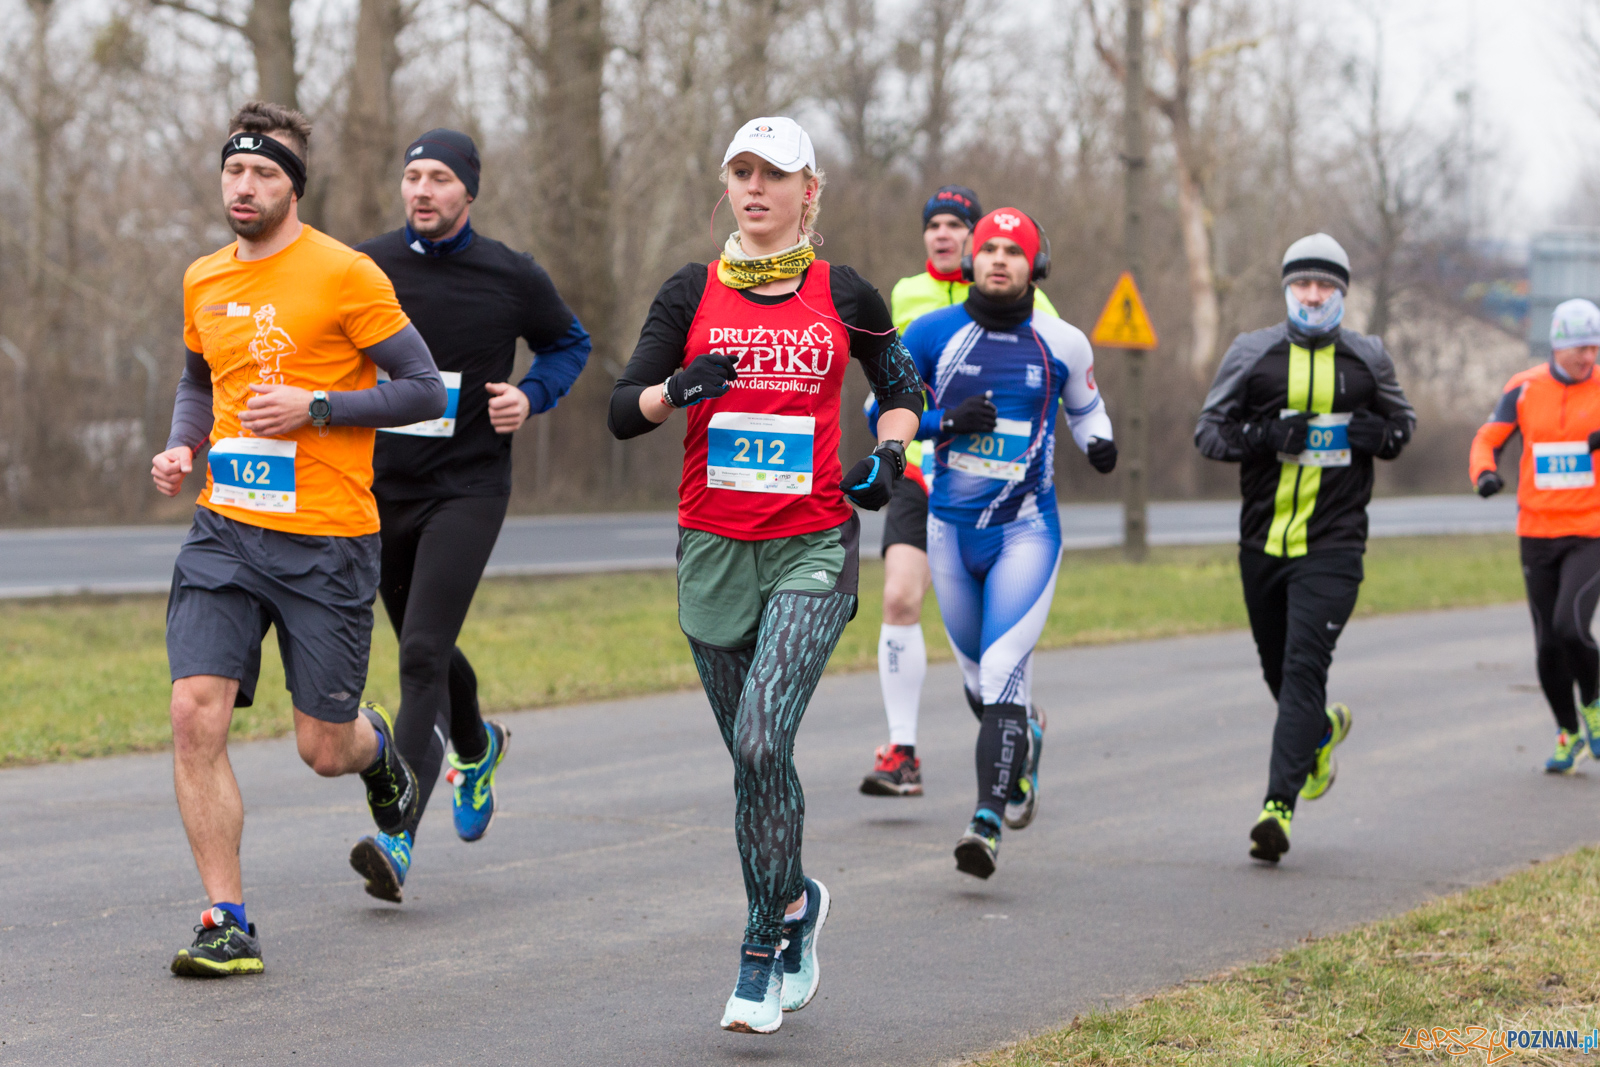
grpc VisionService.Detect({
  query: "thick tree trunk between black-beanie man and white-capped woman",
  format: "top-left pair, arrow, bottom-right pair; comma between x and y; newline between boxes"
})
539,0 -> 621,499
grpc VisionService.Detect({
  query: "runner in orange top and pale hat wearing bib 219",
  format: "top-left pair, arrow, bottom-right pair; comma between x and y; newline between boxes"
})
1469,301 -> 1600,774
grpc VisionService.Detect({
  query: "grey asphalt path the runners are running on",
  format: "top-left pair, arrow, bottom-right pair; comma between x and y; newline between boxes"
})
0,606 -> 1600,1067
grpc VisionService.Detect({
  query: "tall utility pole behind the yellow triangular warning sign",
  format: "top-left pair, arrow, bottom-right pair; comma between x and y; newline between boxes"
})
1117,0 -> 1150,563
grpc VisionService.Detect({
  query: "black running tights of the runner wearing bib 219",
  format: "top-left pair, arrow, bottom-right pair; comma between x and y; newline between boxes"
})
1522,537 -> 1600,733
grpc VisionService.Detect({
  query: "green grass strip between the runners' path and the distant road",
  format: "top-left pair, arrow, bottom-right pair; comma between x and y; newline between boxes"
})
0,534 -> 1523,766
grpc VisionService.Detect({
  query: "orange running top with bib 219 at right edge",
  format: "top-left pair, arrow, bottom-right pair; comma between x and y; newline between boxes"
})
1467,363 -> 1600,537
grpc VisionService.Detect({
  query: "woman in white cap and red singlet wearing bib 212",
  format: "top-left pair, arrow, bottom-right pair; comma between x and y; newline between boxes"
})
610,118 -> 922,1033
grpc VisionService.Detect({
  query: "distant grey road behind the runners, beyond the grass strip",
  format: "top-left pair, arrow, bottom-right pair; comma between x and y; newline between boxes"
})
0,494 -> 1517,598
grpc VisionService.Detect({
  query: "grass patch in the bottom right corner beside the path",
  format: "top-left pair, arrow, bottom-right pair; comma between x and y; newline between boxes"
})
973,848 -> 1600,1067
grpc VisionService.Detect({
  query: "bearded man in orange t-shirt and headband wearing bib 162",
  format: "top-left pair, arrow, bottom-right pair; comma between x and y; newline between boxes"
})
150,104 -> 445,976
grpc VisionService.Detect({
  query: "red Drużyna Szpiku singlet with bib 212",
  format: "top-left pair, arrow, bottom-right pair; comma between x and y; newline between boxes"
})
678,259 -> 853,541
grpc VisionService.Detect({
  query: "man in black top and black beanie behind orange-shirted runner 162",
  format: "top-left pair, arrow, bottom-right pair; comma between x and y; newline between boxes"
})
350,130 -> 589,904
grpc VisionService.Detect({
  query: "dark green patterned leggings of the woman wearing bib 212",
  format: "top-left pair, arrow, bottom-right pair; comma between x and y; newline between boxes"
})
690,592 -> 856,945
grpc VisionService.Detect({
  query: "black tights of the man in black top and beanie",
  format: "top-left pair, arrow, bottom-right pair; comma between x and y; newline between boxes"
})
378,496 -> 507,833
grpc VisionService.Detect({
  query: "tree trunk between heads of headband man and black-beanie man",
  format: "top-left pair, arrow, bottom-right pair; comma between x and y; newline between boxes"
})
339,0 -> 405,243
